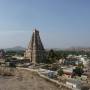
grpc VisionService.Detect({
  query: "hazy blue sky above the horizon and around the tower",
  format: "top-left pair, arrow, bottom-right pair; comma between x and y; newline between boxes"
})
0,0 -> 90,48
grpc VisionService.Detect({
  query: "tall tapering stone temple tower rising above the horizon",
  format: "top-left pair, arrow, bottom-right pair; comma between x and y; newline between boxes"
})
25,29 -> 46,64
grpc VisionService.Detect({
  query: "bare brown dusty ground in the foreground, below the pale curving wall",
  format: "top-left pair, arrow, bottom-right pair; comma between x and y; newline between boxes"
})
0,68 -> 69,90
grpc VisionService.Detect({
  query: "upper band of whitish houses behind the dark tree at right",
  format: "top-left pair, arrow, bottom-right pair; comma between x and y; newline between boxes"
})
59,55 -> 89,66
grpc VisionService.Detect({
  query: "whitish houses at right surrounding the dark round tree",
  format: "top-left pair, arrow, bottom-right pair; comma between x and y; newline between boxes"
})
59,55 -> 90,89
